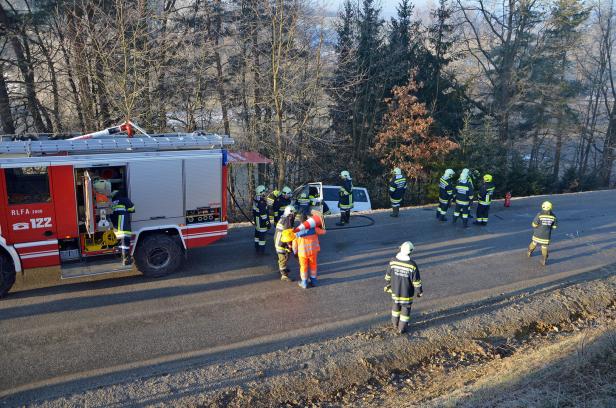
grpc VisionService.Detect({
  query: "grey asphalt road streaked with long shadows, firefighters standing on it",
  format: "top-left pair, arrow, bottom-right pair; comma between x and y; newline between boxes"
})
0,191 -> 616,404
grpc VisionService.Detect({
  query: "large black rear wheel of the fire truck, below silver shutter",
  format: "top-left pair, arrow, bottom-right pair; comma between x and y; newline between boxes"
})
135,234 -> 183,278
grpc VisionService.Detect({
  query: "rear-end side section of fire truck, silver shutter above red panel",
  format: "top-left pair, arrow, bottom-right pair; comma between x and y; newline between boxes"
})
182,154 -> 227,248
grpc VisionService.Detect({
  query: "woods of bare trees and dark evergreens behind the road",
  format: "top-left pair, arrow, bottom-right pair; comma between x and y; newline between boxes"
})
0,0 -> 616,204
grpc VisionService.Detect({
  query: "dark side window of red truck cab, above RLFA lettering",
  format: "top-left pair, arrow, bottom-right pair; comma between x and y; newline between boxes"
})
4,167 -> 51,204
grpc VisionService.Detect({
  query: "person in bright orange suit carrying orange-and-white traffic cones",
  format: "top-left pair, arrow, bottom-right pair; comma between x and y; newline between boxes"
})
292,211 -> 325,289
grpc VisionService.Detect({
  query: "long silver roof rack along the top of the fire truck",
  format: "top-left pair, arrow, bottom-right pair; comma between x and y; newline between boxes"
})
0,132 -> 234,156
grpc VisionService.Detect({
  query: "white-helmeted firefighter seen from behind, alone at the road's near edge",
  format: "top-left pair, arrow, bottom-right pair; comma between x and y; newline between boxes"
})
384,241 -> 423,334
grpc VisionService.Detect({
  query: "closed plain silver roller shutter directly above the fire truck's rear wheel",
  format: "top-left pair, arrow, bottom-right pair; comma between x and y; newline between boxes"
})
128,159 -> 184,233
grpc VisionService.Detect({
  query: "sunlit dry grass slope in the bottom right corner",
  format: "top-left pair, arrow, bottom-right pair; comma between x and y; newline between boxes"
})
440,327 -> 616,408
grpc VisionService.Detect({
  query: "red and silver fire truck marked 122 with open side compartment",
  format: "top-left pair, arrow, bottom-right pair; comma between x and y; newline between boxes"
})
0,128 -> 239,297
